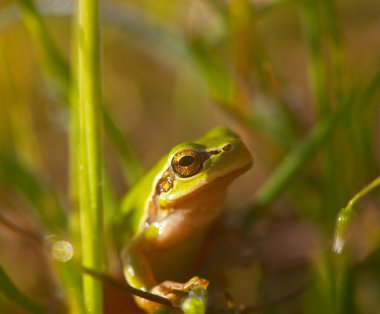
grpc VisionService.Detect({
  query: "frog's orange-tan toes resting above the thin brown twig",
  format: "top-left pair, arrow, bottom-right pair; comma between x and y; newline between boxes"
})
151,276 -> 209,307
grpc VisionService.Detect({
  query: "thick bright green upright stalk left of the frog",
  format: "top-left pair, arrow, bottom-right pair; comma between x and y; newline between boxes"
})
76,0 -> 103,313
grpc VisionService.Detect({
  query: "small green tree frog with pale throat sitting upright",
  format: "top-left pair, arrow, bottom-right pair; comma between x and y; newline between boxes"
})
118,127 -> 252,313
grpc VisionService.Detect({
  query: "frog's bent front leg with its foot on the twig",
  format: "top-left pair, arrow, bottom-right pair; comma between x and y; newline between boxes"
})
122,227 -> 209,313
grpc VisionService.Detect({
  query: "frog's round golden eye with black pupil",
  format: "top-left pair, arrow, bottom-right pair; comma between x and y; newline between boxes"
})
172,149 -> 202,178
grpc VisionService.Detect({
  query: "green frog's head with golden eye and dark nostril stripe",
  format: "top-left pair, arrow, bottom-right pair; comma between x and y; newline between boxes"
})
156,128 -> 252,207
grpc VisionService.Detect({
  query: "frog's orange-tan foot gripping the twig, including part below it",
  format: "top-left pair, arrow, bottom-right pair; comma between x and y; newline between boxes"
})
136,276 -> 209,313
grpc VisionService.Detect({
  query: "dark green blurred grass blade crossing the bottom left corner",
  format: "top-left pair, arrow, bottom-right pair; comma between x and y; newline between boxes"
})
0,266 -> 44,314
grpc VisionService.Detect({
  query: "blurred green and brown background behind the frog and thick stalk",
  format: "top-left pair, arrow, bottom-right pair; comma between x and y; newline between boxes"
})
0,0 -> 380,313
